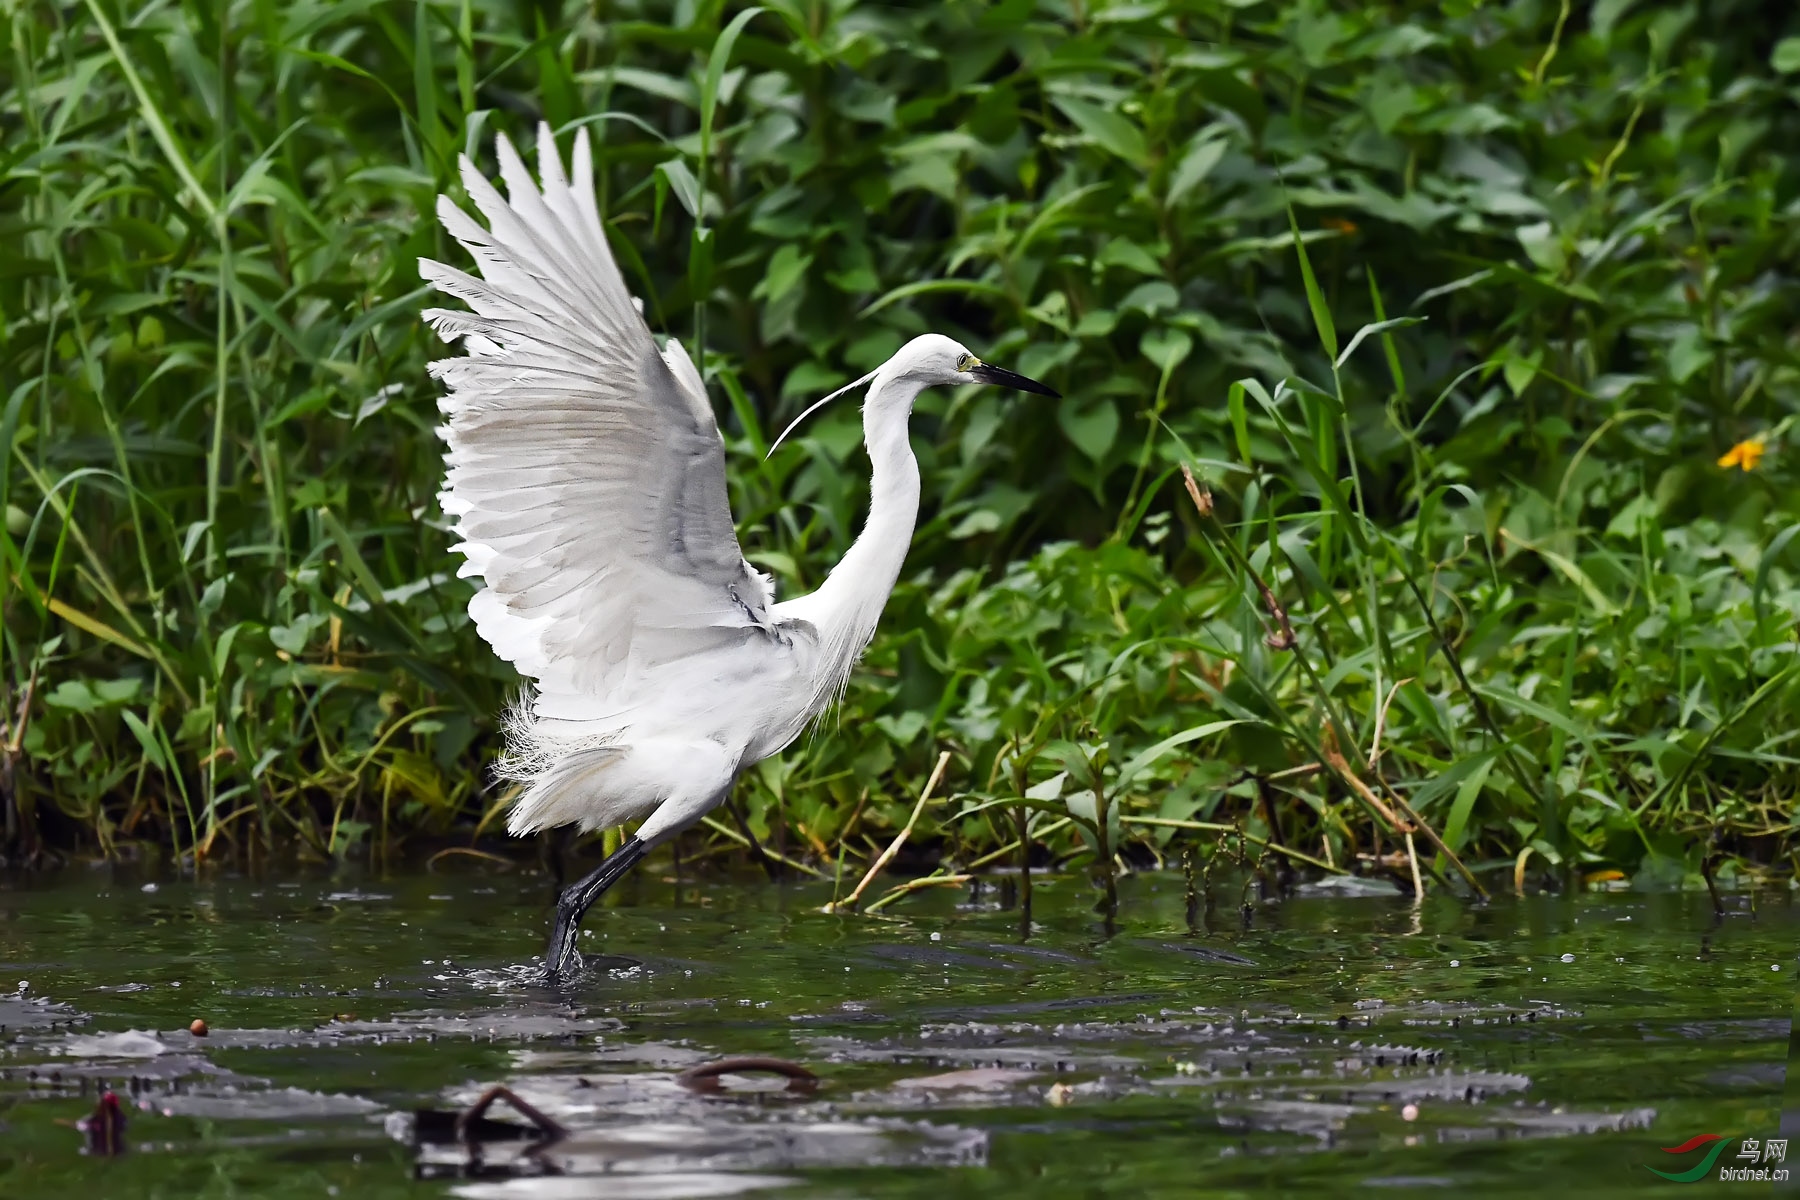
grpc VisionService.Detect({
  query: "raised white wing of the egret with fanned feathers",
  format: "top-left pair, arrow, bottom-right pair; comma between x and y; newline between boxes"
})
419,126 -> 772,718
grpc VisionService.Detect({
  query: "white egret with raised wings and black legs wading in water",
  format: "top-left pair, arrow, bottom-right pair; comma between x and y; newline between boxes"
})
419,126 -> 1057,975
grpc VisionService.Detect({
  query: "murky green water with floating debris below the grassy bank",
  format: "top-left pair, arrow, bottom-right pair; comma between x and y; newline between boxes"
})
0,871 -> 1800,1200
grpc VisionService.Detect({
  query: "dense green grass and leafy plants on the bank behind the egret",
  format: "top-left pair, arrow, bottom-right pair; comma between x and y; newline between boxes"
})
0,0 -> 1800,891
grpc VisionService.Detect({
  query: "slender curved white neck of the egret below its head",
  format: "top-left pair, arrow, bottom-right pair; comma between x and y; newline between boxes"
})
779,374 -> 923,711
